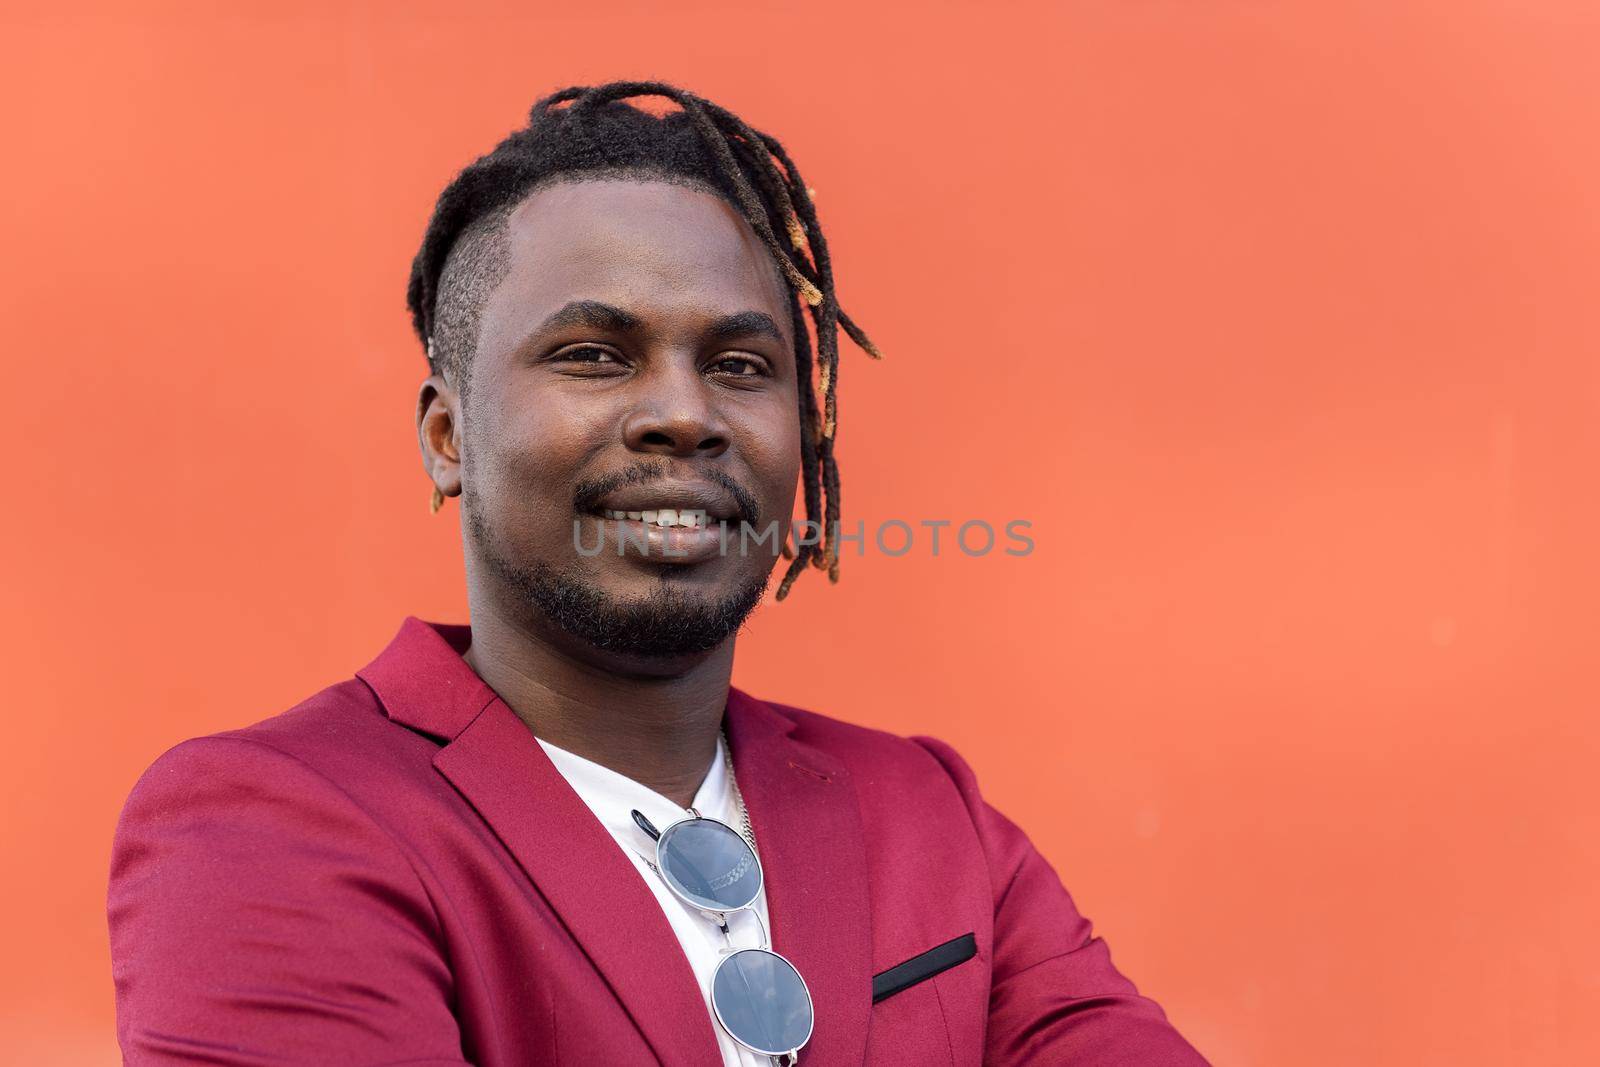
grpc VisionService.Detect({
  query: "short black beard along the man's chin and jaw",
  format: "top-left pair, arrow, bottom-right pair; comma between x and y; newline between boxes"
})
461,493 -> 771,659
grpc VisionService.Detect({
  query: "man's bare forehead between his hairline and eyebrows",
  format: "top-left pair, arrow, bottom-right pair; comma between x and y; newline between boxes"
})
482,179 -> 790,350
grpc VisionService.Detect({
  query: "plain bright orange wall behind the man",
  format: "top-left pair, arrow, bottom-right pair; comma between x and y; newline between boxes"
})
0,0 -> 1600,1065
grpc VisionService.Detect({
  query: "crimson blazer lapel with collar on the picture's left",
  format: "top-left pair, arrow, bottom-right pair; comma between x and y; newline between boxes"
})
357,616 -> 723,1067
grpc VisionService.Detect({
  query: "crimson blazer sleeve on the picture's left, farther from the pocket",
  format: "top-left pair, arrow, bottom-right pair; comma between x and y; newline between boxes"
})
106,734 -> 466,1067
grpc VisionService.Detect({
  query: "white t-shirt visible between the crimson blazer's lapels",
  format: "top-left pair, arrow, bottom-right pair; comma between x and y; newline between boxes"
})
536,734 -> 773,1067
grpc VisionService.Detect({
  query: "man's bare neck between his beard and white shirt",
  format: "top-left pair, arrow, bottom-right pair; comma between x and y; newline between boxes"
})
462,611 -> 733,808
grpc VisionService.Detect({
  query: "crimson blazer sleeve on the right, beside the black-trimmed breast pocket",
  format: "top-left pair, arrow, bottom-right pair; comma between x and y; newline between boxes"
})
912,737 -> 1206,1067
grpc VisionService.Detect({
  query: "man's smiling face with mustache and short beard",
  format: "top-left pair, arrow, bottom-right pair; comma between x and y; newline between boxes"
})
428,181 -> 800,657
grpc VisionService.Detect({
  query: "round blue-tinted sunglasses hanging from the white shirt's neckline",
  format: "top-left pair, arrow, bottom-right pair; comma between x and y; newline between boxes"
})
632,808 -> 816,1064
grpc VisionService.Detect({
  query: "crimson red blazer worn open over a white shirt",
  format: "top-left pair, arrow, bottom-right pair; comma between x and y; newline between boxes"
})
107,617 -> 1205,1067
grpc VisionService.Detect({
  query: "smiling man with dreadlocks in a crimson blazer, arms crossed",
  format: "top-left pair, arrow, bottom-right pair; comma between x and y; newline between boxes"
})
109,83 -> 1203,1067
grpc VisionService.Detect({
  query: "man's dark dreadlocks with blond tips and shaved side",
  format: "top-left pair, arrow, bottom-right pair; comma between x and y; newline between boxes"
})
406,82 -> 882,600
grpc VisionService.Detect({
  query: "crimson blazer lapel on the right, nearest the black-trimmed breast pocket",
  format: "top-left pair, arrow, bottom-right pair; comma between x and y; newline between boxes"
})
723,689 -> 872,1065
